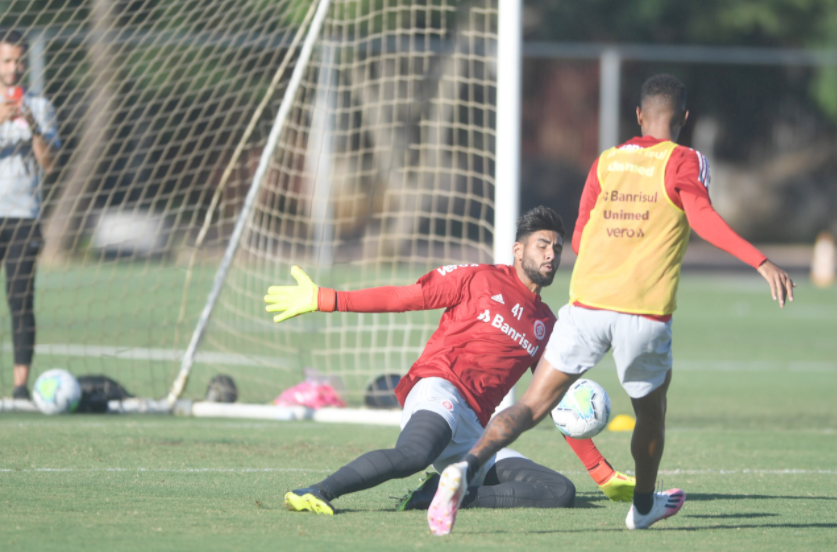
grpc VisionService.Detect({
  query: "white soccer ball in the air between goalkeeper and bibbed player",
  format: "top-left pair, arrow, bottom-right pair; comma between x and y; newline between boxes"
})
552,379 -> 610,439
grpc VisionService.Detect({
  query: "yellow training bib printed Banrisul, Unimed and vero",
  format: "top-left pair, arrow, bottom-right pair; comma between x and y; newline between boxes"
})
570,142 -> 689,315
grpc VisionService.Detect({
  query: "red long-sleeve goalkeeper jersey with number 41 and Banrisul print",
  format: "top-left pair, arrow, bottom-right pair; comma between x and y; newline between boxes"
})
319,265 -> 556,425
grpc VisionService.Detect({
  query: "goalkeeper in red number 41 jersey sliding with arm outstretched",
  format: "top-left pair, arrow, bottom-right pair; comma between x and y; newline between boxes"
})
265,207 -> 635,515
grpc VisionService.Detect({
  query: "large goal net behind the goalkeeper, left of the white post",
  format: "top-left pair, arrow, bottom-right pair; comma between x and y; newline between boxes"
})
0,0 -> 498,406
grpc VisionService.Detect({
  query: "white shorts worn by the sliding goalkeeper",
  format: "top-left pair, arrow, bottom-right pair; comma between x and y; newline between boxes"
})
401,378 -> 525,485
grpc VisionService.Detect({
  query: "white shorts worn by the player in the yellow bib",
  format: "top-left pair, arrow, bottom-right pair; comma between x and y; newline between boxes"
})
543,305 -> 672,399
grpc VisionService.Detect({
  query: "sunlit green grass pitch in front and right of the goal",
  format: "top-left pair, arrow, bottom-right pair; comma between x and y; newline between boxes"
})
0,274 -> 837,551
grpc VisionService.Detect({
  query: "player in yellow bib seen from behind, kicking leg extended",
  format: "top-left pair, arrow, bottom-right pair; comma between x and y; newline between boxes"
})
428,75 -> 794,535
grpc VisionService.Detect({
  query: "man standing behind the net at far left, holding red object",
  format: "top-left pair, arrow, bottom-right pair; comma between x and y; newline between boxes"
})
0,30 -> 61,399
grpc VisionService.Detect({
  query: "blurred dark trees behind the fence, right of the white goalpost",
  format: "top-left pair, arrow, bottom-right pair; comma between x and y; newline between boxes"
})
523,0 -> 837,242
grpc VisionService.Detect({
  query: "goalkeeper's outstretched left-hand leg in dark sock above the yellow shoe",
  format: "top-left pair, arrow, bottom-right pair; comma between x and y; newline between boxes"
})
312,410 -> 452,500
